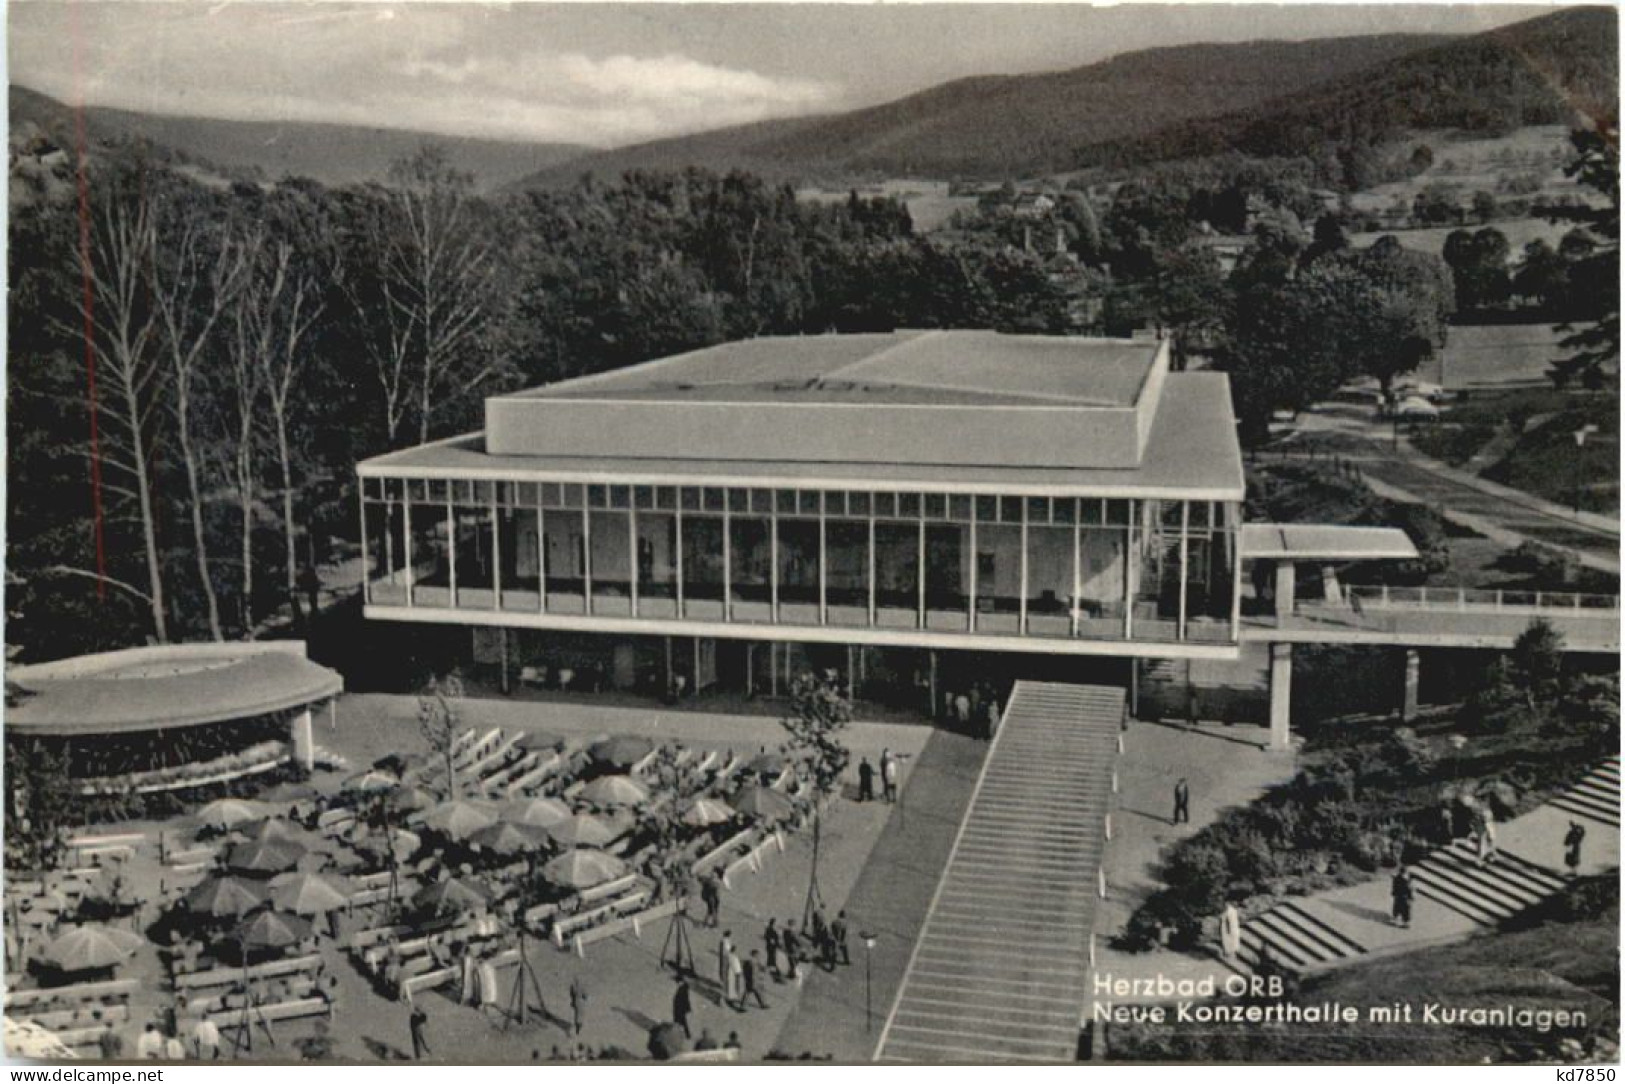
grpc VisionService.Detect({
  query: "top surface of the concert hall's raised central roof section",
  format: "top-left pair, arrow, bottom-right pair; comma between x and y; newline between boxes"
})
504,330 -> 1160,408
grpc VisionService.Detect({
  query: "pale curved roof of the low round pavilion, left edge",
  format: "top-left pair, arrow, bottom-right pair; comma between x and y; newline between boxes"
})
5,640 -> 345,738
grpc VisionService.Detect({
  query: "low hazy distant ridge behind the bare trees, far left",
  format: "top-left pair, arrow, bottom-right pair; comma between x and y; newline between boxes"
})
10,85 -> 587,189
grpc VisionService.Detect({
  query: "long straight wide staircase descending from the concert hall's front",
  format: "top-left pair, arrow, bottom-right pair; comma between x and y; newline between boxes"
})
876,681 -> 1125,1061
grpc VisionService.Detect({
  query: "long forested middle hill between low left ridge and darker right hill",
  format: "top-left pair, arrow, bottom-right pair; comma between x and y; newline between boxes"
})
525,34 -> 1450,185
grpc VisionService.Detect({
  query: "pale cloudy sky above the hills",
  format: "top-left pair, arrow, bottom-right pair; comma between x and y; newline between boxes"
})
8,0 -> 1541,146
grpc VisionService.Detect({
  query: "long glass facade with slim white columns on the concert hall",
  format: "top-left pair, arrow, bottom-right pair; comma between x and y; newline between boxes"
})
362,478 -> 1242,644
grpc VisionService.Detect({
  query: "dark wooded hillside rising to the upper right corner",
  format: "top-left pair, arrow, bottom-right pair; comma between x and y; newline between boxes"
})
1074,8 -> 1619,176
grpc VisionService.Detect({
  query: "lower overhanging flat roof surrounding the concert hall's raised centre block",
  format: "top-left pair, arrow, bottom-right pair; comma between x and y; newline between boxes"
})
358,372 -> 1245,501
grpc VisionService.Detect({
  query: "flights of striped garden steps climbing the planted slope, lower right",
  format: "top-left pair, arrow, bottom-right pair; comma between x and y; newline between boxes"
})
1240,757 -> 1620,973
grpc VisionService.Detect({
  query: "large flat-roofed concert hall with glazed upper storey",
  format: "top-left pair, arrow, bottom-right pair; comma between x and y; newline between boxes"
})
359,332 -> 1267,705
